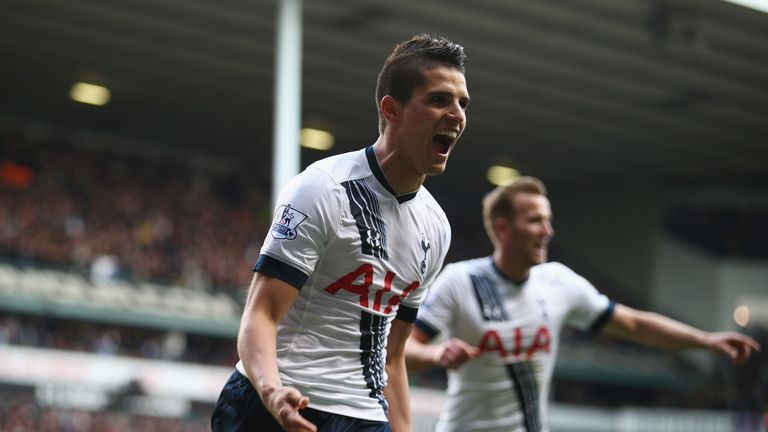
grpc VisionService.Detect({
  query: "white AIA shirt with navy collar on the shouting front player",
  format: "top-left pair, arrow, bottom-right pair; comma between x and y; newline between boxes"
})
237,147 -> 451,421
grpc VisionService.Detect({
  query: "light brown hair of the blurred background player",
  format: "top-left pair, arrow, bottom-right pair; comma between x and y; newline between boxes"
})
483,176 -> 547,245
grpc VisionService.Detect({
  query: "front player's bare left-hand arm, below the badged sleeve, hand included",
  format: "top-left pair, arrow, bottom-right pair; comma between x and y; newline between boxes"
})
237,272 -> 317,432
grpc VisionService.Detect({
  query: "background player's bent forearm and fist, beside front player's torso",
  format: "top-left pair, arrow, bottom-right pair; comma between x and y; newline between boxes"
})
405,326 -> 480,370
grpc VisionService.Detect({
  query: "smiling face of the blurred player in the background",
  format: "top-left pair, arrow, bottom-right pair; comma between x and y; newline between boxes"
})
505,193 -> 555,266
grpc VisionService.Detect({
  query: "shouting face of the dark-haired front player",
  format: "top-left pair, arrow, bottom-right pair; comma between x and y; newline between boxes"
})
397,66 -> 469,175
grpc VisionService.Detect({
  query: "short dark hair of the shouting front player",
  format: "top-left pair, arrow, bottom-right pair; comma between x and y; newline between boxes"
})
376,34 -> 467,132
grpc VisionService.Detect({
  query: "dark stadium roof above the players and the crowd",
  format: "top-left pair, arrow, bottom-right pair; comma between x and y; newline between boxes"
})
0,0 -> 768,194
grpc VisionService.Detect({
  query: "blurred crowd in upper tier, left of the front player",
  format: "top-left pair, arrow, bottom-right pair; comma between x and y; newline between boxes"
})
0,124 -> 270,290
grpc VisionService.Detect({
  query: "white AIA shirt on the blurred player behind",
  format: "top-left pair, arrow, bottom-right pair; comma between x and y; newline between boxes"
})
416,257 -> 613,432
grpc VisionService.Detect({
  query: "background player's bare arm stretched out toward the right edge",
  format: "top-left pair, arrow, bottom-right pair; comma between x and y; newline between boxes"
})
604,304 -> 760,363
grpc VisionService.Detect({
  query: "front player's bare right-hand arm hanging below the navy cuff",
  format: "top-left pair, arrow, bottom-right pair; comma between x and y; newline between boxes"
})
384,319 -> 413,432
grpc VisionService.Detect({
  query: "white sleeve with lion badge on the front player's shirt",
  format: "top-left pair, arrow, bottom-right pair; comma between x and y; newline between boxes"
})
261,168 -> 342,275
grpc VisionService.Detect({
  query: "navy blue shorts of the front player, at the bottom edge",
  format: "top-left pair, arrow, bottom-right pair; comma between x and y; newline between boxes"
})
211,370 -> 391,432
